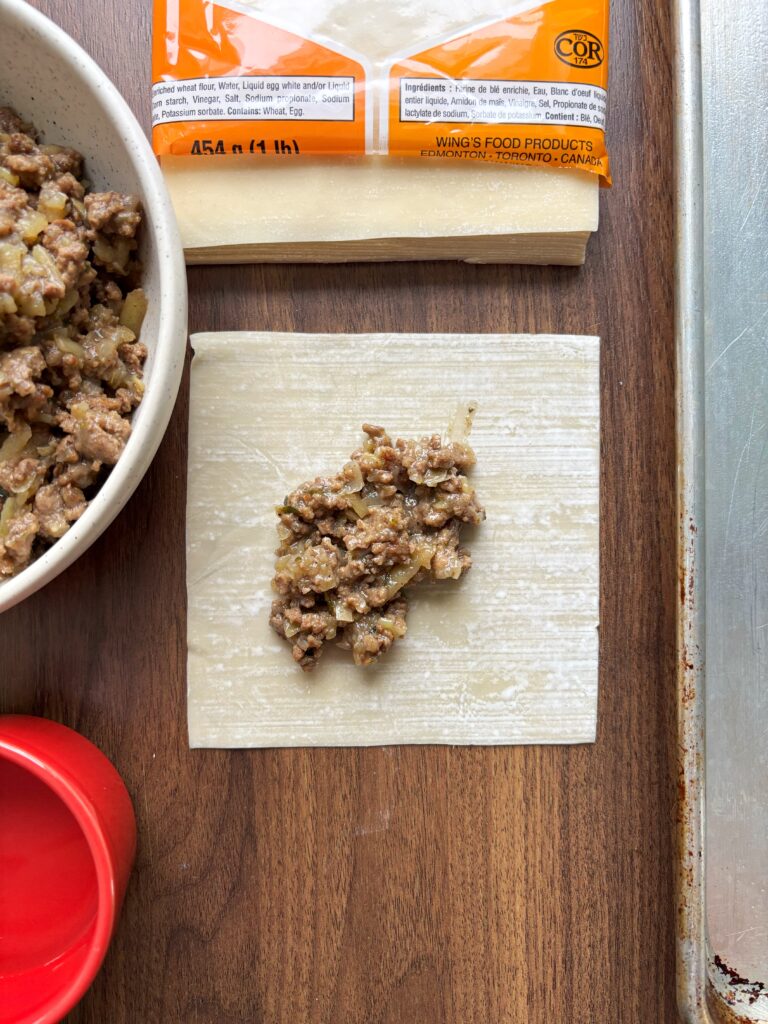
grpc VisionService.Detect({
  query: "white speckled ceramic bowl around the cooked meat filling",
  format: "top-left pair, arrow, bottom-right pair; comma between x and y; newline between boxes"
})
0,0 -> 186,611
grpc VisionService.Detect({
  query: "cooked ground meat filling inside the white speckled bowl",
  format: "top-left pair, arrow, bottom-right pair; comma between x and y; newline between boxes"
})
0,108 -> 146,578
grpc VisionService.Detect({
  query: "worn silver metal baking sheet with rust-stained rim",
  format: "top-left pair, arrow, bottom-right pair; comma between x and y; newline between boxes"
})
676,0 -> 768,1022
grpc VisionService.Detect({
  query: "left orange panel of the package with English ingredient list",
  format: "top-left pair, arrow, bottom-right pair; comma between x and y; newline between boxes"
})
152,0 -> 367,157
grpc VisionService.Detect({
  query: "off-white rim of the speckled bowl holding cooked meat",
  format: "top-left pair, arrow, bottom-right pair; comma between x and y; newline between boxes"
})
0,0 -> 187,612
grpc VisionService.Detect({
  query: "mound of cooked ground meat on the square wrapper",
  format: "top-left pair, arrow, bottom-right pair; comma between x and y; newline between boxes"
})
269,424 -> 485,671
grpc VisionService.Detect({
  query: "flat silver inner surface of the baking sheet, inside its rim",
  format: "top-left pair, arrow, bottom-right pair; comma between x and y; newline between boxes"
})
701,0 -> 768,1003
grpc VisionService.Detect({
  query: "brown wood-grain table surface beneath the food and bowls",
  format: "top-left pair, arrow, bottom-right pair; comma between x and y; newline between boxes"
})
0,0 -> 676,1024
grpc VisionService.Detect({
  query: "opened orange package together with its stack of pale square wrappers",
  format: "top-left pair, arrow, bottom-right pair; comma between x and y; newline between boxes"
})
153,0 -> 610,263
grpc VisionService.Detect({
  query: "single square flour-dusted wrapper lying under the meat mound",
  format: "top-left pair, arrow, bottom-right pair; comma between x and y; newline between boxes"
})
186,332 -> 600,748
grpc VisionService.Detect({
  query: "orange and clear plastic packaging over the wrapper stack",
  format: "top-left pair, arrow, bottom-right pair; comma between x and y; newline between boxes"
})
153,0 -> 610,184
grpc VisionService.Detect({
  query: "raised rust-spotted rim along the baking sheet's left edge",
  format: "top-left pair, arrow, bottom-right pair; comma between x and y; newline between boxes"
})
674,0 -> 715,1024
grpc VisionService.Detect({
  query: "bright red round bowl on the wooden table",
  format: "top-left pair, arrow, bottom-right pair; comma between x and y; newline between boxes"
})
0,715 -> 136,1024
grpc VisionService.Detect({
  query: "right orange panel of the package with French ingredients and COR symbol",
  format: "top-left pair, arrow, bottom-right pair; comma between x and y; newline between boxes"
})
388,0 -> 610,184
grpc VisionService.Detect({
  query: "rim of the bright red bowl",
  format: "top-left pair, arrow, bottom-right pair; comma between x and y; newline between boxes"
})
0,734 -> 119,1024
